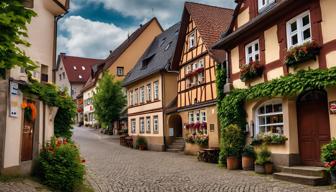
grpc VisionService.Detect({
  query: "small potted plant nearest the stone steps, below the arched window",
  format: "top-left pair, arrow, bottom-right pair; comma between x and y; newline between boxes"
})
254,144 -> 273,174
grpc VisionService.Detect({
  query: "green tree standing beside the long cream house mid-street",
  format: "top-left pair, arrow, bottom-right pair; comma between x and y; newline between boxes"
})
93,73 -> 126,129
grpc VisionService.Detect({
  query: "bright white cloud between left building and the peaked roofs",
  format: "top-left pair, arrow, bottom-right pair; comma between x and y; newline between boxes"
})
58,16 -> 133,58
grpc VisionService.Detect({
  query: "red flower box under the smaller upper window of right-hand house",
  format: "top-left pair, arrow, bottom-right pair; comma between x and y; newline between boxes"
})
240,61 -> 264,82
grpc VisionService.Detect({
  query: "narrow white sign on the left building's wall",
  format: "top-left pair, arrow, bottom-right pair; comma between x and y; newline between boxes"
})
9,81 -> 20,117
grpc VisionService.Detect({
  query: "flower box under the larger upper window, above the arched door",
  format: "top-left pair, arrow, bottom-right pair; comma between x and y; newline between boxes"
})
285,41 -> 321,67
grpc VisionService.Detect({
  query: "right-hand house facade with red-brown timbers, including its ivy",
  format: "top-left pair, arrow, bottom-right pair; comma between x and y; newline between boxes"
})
214,0 -> 336,166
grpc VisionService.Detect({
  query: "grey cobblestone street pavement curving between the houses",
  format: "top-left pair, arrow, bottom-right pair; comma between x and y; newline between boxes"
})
74,128 -> 332,192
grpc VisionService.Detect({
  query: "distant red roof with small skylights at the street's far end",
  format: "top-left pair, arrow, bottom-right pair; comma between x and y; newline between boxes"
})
58,53 -> 104,84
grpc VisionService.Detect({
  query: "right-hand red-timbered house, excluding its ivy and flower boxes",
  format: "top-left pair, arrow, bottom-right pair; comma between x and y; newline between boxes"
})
216,0 -> 336,169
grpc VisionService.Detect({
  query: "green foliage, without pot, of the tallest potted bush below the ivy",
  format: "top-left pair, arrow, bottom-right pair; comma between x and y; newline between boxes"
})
221,125 -> 245,163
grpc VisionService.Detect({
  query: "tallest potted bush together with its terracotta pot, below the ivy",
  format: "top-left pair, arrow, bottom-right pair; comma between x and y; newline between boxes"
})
222,125 -> 245,170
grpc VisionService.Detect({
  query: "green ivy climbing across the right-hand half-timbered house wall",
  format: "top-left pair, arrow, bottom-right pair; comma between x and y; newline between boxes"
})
217,67 -> 336,164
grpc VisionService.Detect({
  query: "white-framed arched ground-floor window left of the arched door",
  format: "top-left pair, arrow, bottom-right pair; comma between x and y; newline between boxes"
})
256,101 -> 284,134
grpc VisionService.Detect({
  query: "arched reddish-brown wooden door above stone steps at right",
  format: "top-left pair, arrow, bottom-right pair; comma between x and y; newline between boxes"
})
297,90 -> 330,166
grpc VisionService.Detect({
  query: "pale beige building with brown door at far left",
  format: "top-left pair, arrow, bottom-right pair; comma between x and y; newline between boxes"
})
0,0 -> 69,174
